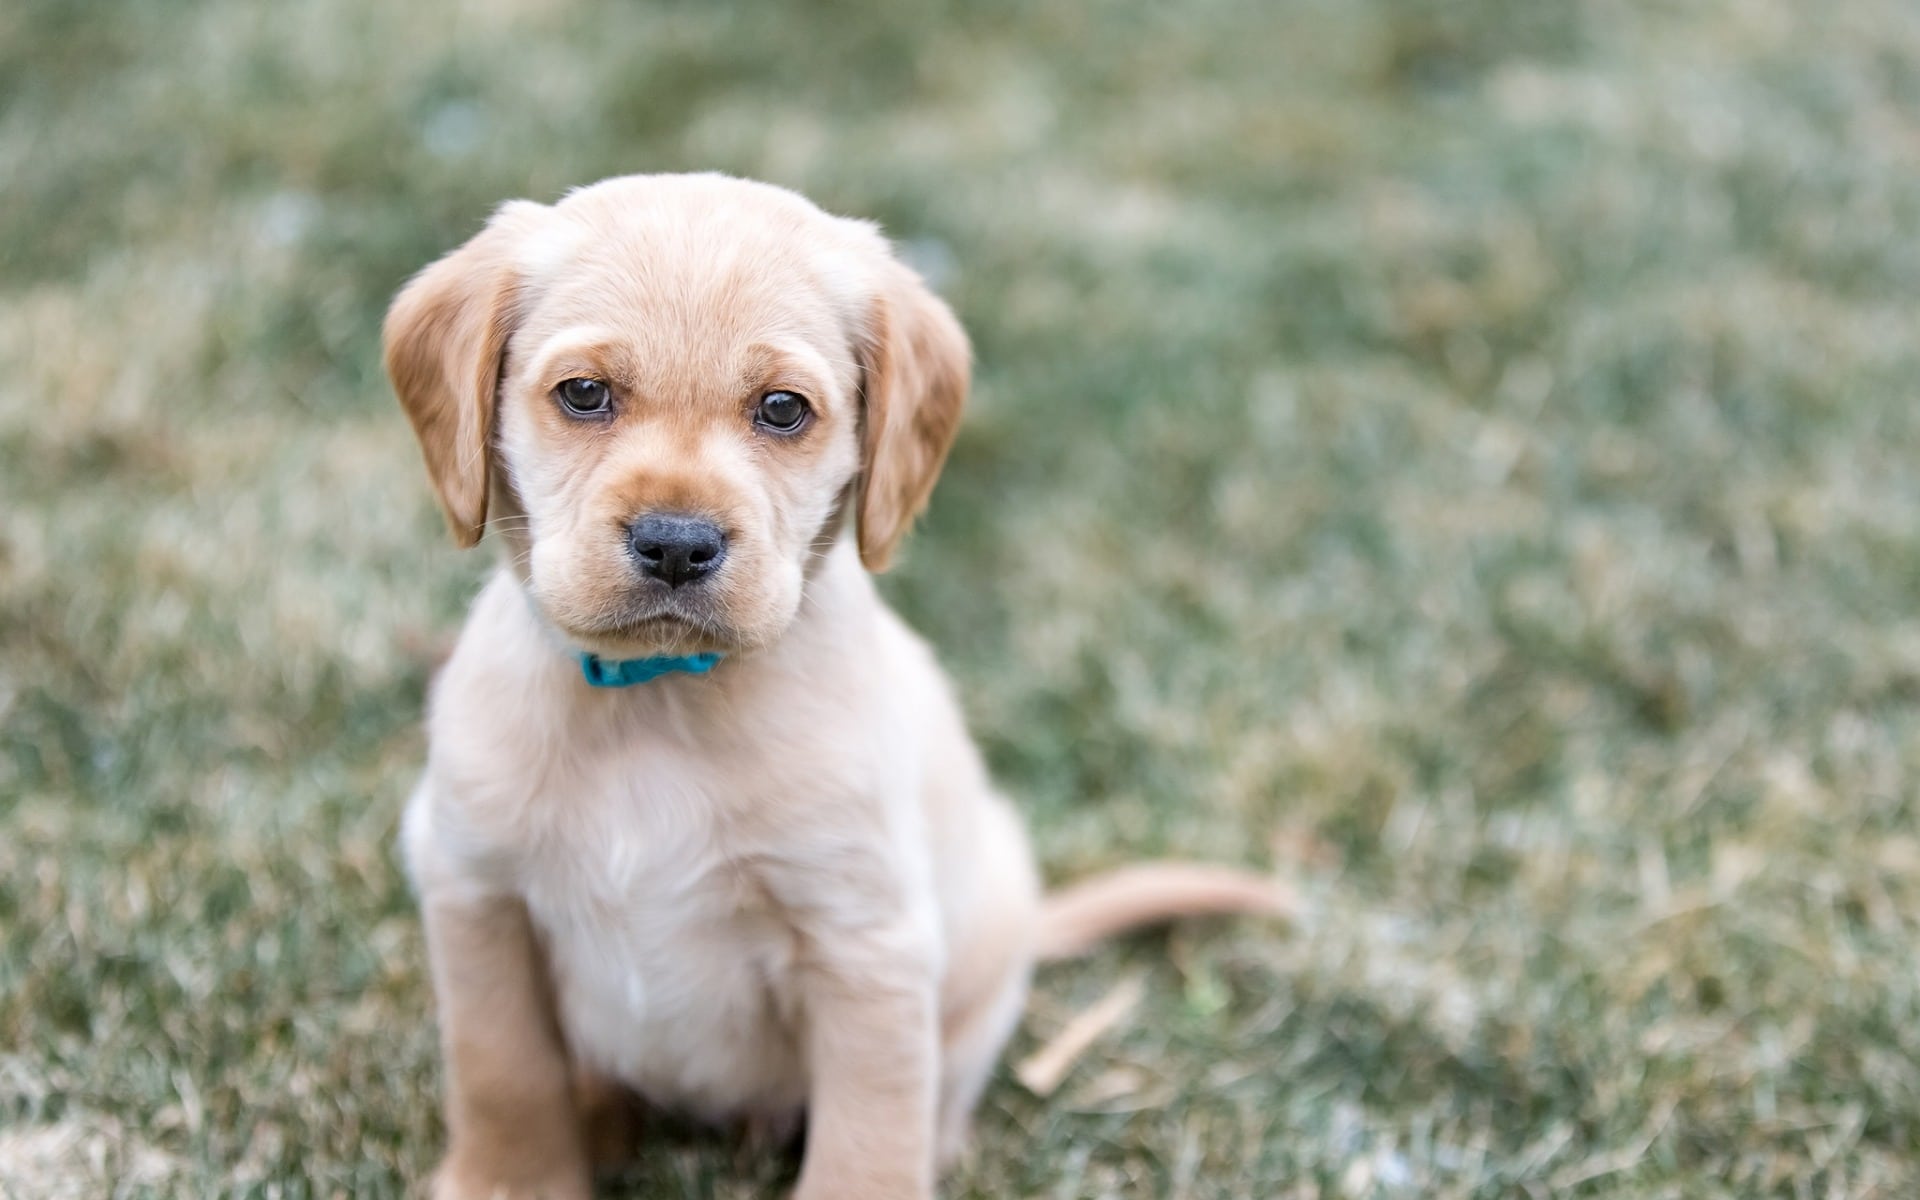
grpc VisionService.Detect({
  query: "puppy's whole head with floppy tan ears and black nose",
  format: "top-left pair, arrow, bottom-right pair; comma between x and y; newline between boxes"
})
386,175 -> 968,655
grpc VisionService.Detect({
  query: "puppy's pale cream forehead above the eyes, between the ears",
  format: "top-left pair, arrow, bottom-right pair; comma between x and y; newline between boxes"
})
515,204 -> 870,388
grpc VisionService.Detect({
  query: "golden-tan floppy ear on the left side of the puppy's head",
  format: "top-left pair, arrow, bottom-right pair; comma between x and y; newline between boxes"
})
382,200 -> 547,547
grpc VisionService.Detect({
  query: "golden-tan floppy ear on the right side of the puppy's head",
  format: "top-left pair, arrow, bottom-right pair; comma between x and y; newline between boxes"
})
858,255 -> 972,570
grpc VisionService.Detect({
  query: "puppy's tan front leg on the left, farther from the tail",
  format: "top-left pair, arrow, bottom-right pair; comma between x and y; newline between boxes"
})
422,895 -> 591,1200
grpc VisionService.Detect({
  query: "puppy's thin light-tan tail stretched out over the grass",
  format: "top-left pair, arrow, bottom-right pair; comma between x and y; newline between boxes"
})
1035,862 -> 1298,960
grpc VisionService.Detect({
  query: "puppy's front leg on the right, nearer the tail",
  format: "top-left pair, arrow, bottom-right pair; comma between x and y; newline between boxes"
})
793,935 -> 939,1200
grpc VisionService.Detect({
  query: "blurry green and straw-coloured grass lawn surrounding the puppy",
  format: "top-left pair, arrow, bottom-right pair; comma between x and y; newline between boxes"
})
0,0 -> 1920,1200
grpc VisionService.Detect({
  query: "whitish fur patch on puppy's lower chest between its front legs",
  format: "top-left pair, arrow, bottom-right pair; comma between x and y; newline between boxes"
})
516,753 -> 806,1117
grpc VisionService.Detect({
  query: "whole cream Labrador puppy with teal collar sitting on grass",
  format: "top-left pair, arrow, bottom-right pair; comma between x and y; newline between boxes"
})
386,175 -> 1281,1200
